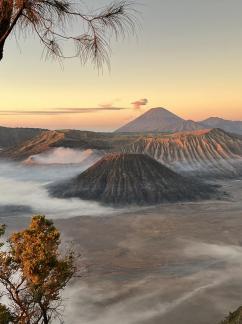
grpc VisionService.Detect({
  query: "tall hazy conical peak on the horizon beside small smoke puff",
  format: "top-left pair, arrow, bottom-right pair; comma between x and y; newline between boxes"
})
116,108 -> 205,133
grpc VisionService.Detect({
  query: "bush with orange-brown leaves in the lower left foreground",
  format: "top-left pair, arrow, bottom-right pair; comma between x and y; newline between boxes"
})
0,216 -> 76,324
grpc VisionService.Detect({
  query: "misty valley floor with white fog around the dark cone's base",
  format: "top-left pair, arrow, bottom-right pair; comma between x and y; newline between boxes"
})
0,150 -> 242,324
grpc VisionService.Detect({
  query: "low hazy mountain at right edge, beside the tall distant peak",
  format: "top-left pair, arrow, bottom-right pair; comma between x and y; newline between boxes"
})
200,117 -> 242,134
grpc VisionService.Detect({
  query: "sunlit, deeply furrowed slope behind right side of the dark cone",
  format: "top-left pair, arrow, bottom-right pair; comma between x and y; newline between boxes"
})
122,129 -> 242,177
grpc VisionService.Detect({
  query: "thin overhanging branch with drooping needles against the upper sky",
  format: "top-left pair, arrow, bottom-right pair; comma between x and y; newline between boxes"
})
0,0 -> 137,68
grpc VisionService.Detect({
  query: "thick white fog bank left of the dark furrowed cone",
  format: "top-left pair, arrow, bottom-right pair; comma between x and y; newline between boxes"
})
0,149 -> 113,218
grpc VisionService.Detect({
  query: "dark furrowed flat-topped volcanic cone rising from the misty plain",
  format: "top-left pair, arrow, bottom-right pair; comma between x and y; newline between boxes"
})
49,154 -> 216,206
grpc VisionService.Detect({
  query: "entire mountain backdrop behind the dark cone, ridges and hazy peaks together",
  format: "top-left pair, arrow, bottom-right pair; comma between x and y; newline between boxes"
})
0,108 -> 242,177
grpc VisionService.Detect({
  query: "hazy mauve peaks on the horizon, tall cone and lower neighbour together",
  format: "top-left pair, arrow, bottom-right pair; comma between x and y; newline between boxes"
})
116,108 -> 242,134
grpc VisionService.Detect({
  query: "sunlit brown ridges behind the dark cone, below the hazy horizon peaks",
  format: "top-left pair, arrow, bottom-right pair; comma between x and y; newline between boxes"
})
0,128 -> 242,178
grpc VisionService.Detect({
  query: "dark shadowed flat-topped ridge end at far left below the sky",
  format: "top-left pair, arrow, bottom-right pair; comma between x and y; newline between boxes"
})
0,126 -> 43,148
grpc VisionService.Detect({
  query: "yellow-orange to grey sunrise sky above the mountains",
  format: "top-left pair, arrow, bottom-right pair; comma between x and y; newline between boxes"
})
0,0 -> 242,131
